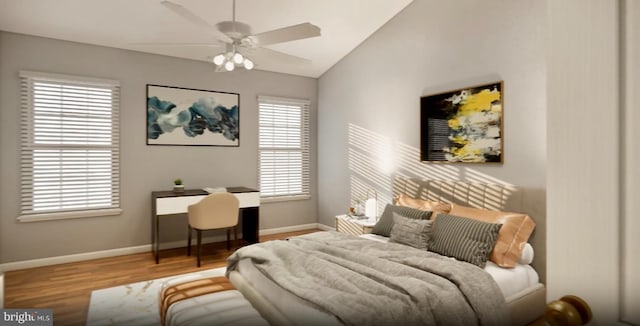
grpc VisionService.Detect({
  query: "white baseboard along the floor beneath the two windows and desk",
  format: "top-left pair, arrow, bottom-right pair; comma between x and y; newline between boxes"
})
0,223 -> 322,272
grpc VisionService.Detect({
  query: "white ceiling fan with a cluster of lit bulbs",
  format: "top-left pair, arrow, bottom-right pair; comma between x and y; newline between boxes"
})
158,0 -> 320,71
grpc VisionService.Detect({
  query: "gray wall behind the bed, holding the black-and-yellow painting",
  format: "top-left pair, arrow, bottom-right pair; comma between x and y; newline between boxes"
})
318,0 -> 546,225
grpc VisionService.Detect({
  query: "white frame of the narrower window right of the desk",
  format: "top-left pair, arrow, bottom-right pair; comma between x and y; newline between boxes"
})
258,95 -> 311,202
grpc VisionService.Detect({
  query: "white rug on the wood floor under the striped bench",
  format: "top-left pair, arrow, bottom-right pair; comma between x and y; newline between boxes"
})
87,267 -> 227,326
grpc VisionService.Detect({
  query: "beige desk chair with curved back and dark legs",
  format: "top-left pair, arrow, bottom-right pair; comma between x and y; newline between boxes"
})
187,192 -> 240,267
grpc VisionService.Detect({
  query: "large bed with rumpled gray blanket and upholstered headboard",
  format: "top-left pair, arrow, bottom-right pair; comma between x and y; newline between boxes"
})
162,178 -> 545,325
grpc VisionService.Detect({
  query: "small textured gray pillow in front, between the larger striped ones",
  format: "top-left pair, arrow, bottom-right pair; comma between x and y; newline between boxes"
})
389,212 -> 433,250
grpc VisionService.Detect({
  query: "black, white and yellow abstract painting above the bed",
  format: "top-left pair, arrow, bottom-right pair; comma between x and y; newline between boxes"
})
420,81 -> 504,164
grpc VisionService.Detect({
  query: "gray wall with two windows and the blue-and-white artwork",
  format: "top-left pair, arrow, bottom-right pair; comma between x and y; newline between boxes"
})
0,32 -> 317,263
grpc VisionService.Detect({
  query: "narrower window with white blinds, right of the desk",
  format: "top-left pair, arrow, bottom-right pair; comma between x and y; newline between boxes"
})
258,96 -> 310,200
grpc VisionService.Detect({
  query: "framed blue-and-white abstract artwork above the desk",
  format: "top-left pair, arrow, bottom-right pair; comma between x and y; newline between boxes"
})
147,85 -> 240,146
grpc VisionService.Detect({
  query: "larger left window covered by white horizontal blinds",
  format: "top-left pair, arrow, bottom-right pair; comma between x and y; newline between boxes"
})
18,71 -> 121,221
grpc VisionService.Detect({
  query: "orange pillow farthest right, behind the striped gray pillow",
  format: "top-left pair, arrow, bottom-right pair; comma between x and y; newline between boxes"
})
449,204 -> 536,268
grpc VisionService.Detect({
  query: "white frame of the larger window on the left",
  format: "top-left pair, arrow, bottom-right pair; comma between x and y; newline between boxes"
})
17,71 -> 122,222
